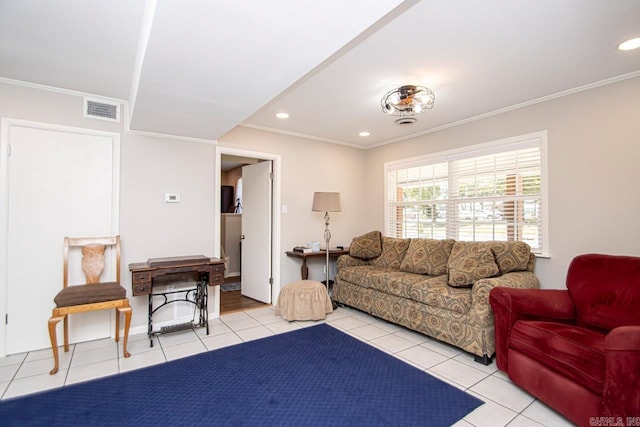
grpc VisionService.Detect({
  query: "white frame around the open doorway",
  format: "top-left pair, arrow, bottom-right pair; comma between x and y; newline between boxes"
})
212,145 -> 282,317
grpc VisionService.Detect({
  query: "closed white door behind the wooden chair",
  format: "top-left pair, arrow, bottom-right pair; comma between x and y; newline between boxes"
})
5,120 -> 119,354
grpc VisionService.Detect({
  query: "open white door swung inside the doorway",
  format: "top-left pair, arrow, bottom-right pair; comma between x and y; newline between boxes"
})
241,160 -> 273,304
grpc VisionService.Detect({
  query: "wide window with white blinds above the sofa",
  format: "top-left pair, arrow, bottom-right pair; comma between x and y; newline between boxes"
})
385,132 -> 548,255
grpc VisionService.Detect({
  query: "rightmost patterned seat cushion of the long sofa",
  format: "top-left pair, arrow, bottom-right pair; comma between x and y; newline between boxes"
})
411,274 -> 471,314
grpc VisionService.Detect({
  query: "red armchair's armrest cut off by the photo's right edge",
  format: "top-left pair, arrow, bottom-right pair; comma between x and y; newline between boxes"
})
603,326 -> 640,419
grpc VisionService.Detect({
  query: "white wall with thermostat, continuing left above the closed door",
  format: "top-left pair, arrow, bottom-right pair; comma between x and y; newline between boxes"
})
0,83 -> 214,331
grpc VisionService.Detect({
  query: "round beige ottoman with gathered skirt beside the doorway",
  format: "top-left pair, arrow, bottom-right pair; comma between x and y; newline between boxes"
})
276,280 -> 333,321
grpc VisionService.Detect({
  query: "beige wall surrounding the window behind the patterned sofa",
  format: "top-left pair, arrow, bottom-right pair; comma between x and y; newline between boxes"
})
365,78 -> 640,288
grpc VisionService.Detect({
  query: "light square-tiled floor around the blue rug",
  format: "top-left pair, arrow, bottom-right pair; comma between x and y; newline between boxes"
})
0,307 -> 572,427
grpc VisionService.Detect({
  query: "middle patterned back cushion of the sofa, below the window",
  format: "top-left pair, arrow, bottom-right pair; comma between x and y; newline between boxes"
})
400,239 -> 455,276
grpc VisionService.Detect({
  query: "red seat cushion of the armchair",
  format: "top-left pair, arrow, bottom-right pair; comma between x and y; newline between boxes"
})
509,320 -> 606,395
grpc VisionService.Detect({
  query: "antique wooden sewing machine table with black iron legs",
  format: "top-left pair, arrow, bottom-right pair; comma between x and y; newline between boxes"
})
129,255 -> 224,347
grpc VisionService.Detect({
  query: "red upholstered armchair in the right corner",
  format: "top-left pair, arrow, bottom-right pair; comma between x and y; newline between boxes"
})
489,254 -> 640,426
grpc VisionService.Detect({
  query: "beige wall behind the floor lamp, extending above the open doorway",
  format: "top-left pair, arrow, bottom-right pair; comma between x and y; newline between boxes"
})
218,127 -> 367,285
